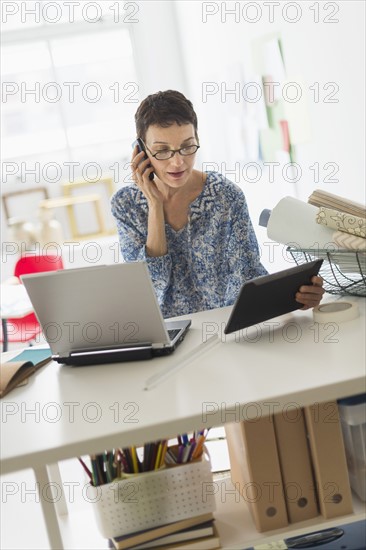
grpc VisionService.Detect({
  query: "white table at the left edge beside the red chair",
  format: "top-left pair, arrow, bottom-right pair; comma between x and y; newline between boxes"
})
0,284 -> 34,351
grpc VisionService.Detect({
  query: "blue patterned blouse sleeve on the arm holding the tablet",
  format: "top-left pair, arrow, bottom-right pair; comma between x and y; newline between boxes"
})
225,192 -> 267,305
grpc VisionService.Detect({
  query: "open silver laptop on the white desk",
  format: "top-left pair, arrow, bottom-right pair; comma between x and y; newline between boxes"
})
21,262 -> 191,366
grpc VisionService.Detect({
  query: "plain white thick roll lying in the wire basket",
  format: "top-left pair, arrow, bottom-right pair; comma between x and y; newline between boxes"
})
267,197 -> 335,250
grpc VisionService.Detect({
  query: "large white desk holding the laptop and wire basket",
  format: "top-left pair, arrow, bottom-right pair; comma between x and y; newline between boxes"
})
0,299 -> 365,548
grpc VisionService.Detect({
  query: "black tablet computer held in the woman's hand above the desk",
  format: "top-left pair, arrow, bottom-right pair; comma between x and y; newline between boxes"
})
224,260 -> 323,334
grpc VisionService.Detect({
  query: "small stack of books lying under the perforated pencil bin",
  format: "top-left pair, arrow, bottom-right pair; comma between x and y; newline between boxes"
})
109,513 -> 220,550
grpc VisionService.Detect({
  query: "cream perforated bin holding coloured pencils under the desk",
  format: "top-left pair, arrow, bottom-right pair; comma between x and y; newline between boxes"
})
87,456 -> 215,538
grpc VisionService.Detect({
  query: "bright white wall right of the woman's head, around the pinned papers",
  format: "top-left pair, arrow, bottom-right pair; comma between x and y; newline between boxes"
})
175,0 -> 366,272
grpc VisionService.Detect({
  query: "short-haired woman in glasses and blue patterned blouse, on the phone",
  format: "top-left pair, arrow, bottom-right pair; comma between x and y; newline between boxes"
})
112,90 -> 324,318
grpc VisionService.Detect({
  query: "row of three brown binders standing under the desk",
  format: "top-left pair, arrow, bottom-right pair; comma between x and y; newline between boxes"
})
225,402 -> 353,532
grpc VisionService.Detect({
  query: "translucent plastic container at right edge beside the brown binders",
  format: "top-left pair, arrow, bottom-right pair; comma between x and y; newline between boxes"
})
338,393 -> 366,502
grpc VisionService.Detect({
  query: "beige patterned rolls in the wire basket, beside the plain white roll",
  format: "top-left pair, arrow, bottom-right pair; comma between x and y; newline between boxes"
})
308,189 -> 366,250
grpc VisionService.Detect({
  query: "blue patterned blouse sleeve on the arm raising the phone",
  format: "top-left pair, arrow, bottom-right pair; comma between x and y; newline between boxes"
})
111,191 -> 172,303
